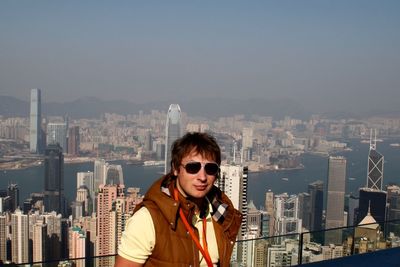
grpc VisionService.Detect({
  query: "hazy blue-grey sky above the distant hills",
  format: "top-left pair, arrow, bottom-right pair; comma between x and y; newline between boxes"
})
0,0 -> 400,111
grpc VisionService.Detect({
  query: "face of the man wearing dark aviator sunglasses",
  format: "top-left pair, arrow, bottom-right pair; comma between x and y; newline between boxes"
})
174,151 -> 216,198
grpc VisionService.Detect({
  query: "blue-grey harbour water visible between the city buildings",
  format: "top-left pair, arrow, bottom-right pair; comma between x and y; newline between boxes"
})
0,140 -> 400,210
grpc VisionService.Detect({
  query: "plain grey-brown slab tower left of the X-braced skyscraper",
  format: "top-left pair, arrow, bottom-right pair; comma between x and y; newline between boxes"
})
325,157 -> 346,244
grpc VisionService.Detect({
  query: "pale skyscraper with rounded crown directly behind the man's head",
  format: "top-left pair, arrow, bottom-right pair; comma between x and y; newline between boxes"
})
164,104 -> 182,173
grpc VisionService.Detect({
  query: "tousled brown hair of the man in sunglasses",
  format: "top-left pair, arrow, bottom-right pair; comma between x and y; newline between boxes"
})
170,132 -> 221,175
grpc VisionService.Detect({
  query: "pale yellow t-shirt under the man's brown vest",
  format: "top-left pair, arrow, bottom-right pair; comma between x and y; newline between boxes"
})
118,204 -> 219,266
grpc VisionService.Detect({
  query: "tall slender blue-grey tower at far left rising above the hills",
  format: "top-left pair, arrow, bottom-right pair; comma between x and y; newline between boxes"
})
29,89 -> 42,154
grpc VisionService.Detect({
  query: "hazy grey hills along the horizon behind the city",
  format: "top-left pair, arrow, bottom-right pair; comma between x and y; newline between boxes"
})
0,96 -> 400,119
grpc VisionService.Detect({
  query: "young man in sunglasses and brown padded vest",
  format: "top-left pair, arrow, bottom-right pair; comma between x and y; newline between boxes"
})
115,133 -> 242,267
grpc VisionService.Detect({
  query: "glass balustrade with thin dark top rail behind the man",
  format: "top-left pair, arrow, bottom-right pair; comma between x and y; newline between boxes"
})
5,220 -> 400,267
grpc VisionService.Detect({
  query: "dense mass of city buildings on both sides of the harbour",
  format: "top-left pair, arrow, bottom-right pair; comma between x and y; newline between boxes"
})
0,89 -> 400,266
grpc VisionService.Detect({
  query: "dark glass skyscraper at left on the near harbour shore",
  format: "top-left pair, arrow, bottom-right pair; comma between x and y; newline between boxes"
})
44,144 -> 65,215
